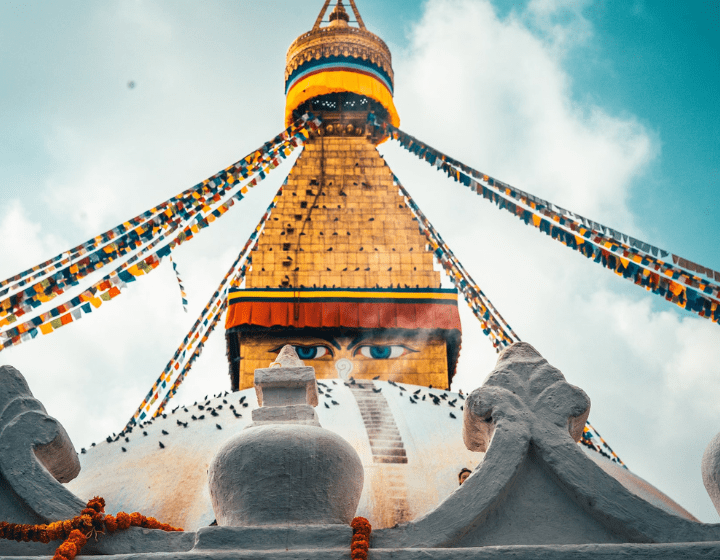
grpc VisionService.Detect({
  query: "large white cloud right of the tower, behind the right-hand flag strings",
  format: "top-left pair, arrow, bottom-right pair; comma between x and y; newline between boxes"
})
381,0 -> 720,521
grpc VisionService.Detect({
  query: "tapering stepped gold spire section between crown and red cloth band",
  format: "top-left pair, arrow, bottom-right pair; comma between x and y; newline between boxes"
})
245,136 -> 440,288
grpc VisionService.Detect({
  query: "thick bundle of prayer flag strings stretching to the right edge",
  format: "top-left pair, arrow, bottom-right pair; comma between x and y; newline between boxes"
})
380,123 -> 720,323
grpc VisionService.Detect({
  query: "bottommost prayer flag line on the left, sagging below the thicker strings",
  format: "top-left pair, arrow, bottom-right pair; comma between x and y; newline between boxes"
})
0,115 -> 319,351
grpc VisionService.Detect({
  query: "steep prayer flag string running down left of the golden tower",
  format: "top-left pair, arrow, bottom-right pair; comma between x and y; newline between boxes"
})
125,187 -> 283,429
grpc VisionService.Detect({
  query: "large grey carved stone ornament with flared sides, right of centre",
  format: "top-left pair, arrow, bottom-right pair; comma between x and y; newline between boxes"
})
373,342 -> 720,548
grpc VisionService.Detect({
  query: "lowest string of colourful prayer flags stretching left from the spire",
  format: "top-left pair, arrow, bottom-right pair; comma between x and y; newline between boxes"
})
0,115 -> 319,351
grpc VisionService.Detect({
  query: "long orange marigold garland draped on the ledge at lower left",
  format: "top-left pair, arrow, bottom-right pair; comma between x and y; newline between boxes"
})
0,496 -> 182,560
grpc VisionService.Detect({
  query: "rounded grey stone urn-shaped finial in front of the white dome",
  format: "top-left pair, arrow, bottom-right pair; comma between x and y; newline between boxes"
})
208,345 -> 364,527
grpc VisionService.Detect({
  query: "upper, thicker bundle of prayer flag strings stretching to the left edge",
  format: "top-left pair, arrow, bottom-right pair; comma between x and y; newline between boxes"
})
0,111 -> 318,327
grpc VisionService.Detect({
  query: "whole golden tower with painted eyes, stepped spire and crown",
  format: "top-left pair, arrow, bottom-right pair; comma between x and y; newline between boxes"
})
226,0 -> 461,390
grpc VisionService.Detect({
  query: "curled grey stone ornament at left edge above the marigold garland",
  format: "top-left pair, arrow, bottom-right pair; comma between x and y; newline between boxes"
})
0,366 -> 85,524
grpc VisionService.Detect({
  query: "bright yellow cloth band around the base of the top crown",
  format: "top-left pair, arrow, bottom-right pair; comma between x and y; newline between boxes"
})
285,70 -> 400,127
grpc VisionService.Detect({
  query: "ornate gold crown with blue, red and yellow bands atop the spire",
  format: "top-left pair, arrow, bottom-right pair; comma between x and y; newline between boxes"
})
285,0 -> 400,126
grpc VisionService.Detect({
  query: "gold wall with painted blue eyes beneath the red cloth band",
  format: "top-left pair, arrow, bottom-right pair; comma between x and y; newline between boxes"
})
239,329 -> 448,390
